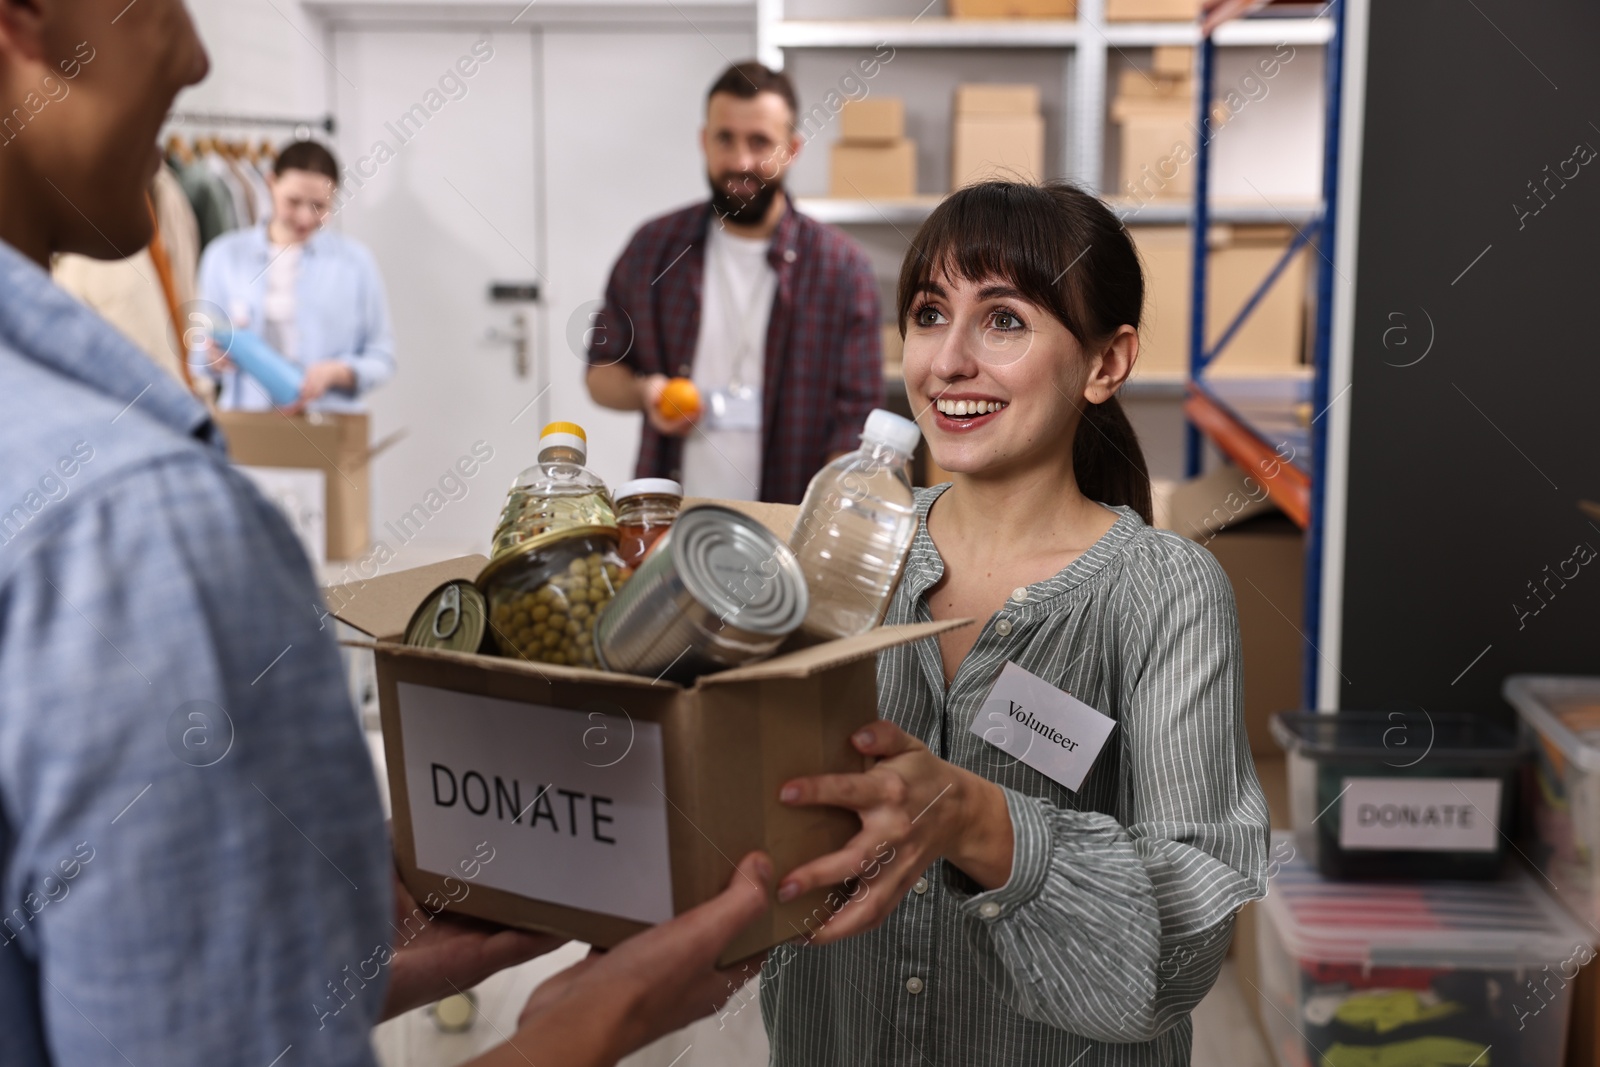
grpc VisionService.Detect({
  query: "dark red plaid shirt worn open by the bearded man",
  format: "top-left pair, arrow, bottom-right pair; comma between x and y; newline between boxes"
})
589,202 -> 883,504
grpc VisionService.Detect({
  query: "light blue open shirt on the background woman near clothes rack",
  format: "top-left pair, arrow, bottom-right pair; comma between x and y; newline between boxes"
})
190,222 -> 395,413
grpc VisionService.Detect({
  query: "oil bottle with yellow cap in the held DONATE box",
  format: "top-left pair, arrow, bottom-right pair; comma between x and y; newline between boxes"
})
490,422 -> 616,558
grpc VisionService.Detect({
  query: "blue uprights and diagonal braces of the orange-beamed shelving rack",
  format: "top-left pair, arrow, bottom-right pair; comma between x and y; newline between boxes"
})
1184,0 -> 1344,709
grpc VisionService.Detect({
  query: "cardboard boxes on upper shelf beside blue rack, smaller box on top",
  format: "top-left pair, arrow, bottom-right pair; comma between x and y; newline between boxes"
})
1110,45 -> 1195,202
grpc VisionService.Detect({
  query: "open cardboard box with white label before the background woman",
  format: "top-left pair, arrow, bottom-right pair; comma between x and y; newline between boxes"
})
216,411 -> 381,563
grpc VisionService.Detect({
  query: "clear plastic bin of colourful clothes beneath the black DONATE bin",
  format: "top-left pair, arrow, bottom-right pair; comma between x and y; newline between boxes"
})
1258,833 -> 1594,1067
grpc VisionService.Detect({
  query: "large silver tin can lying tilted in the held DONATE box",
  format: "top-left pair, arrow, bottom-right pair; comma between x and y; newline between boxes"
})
595,506 -> 810,683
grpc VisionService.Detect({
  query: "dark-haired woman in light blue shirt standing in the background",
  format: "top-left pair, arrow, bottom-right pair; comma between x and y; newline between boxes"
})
192,141 -> 395,413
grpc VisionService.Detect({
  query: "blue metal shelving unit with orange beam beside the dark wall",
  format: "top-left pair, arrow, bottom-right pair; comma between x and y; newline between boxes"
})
1184,0 -> 1344,707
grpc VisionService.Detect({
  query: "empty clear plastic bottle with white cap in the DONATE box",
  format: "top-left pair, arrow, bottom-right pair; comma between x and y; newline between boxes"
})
789,410 -> 922,640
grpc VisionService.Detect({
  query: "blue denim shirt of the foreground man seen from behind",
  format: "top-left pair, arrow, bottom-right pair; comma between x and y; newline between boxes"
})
0,243 -> 394,1067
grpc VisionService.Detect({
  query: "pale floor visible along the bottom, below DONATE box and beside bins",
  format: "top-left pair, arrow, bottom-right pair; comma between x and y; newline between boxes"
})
373,945 -> 1272,1067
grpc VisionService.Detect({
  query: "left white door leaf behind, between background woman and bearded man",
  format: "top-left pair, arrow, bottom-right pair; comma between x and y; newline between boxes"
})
331,29 -> 549,559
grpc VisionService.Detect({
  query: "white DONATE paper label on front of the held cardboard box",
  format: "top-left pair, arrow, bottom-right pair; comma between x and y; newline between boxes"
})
397,681 -> 672,923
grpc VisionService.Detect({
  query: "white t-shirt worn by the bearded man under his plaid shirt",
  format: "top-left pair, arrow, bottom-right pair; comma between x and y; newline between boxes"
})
683,219 -> 778,501
